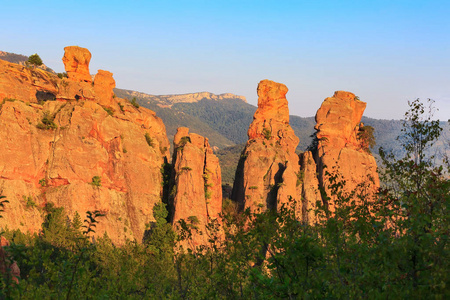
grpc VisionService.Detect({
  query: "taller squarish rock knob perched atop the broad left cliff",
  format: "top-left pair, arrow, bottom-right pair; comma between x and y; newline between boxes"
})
63,46 -> 92,83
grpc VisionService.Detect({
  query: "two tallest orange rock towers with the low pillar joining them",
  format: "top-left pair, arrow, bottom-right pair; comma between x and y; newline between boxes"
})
232,80 -> 379,224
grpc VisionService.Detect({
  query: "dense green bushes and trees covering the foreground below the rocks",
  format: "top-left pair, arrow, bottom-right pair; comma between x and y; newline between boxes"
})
0,101 -> 450,299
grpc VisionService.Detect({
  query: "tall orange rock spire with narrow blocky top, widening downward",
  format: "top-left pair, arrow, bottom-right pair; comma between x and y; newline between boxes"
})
232,80 -> 301,212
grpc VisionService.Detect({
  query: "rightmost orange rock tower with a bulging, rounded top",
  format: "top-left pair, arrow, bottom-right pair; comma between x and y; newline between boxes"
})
315,91 -> 379,210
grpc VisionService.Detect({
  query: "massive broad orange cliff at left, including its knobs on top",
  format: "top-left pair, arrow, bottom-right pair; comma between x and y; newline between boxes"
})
0,47 -> 170,243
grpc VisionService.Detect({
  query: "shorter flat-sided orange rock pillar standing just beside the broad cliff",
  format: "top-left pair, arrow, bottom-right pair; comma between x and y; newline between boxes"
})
172,127 -> 222,249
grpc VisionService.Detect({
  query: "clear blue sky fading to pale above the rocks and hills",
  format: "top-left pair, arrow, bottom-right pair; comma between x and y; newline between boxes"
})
0,0 -> 450,120
